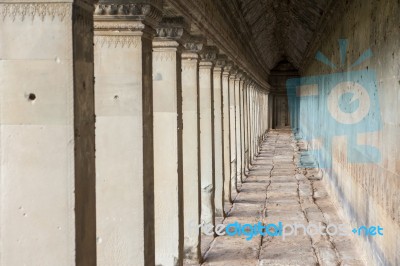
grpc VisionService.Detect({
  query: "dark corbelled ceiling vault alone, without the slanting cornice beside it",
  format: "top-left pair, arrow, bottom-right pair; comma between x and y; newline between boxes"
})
236,0 -> 331,70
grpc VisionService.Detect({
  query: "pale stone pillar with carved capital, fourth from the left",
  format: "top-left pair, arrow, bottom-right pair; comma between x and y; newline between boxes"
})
182,40 -> 203,263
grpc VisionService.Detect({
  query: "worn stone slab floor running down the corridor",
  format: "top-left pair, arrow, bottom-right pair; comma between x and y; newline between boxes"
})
197,130 -> 365,266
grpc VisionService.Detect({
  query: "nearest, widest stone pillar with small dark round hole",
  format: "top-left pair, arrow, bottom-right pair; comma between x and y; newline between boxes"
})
0,1 -> 96,265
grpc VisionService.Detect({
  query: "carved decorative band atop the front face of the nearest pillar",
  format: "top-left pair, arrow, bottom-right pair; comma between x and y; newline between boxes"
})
0,3 -> 72,21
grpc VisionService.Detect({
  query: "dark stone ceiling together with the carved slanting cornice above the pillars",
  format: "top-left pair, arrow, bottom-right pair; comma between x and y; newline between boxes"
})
164,0 -> 336,82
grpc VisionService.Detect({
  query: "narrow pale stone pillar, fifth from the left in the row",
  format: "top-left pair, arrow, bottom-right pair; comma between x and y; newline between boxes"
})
199,46 -> 217,229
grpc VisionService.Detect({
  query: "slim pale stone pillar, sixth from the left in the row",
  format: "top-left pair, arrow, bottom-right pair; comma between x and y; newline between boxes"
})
213,55 -> 226,217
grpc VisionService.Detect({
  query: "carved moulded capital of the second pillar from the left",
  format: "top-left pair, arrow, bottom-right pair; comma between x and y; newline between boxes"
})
93,0 -> 163,30
